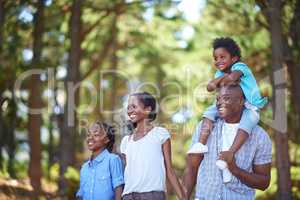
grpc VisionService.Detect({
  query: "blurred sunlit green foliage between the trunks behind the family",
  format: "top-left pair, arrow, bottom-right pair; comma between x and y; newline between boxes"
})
0,0 -> 299,199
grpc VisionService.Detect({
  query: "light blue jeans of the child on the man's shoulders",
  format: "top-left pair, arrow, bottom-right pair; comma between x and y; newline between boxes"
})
203,102 -> 260,135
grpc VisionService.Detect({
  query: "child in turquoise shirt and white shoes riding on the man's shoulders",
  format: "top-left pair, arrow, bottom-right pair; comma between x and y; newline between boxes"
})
188,38 -> 267,182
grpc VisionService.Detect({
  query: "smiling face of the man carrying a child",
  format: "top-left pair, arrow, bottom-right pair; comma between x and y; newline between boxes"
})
217,87 -> 244,120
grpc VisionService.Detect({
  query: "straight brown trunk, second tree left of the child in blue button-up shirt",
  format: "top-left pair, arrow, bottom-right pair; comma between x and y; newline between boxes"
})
28,0 -> 44,192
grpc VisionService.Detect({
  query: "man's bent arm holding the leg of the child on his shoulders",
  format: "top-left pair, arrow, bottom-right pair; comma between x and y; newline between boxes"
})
220,151 -> 271,190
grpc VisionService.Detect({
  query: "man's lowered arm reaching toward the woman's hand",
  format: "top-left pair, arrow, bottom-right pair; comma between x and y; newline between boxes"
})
183,154 -> 203,199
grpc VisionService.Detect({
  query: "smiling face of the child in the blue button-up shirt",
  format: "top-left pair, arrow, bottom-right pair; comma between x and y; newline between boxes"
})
86,124 -> 109,152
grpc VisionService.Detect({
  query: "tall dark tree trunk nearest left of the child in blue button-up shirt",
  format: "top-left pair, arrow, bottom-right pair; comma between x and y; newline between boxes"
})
59,0 -> 83,193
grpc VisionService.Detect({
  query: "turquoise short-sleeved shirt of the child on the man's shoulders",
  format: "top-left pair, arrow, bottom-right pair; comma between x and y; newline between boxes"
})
215,62 -> 267,109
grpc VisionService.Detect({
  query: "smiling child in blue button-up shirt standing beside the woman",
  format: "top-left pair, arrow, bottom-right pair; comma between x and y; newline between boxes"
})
76,122 -> 124,200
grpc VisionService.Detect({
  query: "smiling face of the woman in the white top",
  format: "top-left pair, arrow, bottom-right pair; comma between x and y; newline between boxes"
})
127,96 -> 151,123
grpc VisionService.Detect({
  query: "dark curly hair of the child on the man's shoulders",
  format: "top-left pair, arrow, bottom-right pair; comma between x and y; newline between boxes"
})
213,37 -> 242,60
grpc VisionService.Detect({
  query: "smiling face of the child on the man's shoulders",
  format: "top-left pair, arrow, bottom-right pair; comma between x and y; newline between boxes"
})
213,47 -> 238,72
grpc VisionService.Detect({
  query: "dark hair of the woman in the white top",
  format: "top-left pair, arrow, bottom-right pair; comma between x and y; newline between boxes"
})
127,92 -> 157,132
